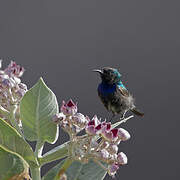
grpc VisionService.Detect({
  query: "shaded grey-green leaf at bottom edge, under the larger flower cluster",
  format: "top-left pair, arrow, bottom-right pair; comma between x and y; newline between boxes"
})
42,160 -> 106,180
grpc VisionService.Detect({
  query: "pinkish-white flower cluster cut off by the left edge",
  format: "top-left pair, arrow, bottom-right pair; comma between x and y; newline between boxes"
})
0,60 -> 27,125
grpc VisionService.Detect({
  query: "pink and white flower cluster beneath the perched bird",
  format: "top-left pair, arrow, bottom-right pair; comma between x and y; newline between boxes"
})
53,100 -> 130,176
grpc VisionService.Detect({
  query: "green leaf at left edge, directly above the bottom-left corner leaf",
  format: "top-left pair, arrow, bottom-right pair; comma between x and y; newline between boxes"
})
0,119 -> 38,166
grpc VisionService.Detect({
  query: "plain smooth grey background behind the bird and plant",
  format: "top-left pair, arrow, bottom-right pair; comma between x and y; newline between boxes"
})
0,0 -> 180,180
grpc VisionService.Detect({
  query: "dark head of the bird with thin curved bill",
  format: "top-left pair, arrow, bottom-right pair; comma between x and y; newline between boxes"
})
93,67 -> 121,84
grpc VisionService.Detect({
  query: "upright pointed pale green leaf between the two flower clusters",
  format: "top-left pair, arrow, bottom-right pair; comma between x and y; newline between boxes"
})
20,78 -> 59,143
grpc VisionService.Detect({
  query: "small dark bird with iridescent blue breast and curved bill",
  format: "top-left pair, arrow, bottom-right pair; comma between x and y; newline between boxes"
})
93,67 -> 144,119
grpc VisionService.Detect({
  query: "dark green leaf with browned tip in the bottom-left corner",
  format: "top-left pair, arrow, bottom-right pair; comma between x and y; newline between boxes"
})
0,145 -> 29,180
